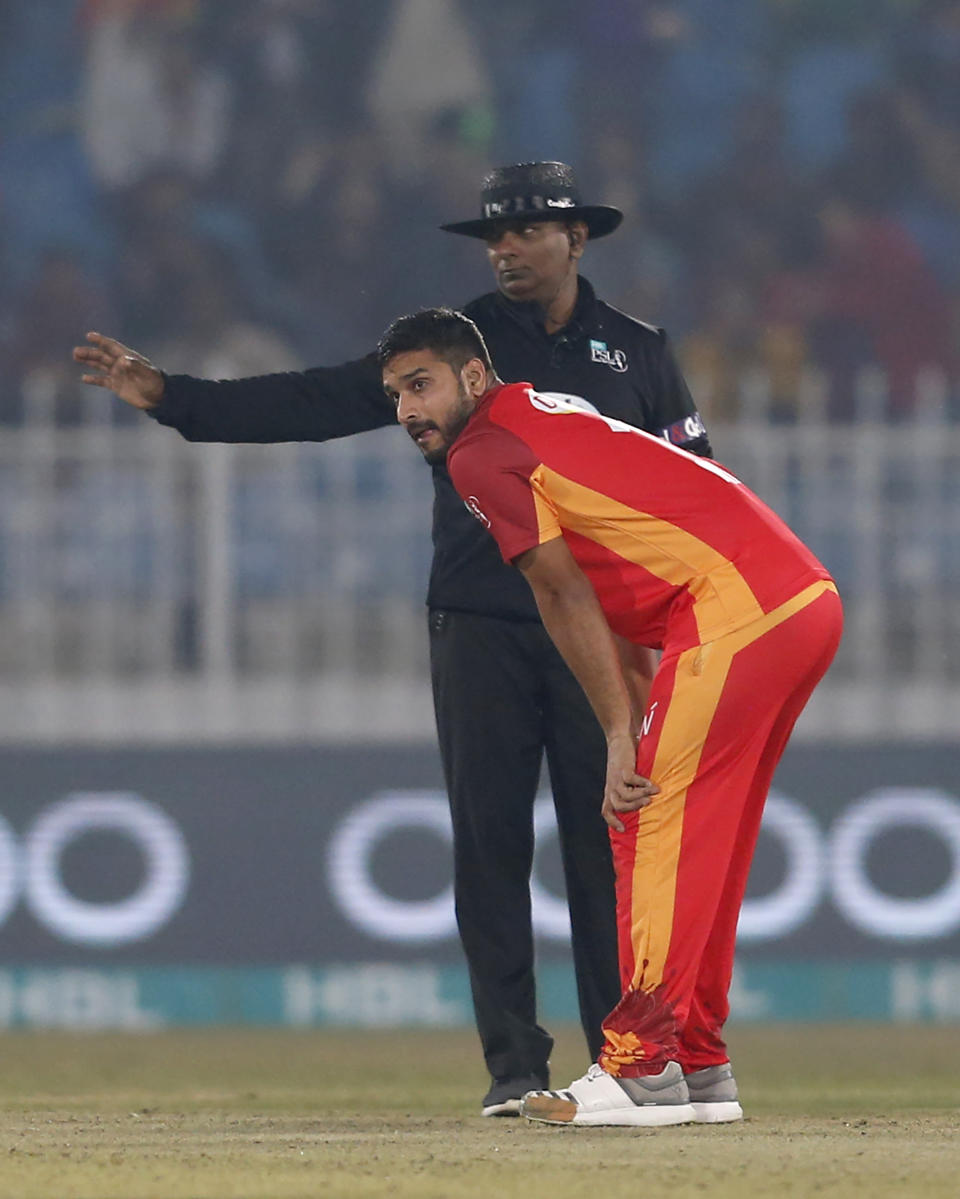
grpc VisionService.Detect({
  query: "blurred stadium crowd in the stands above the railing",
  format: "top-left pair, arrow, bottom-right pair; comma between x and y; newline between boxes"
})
0,0 -> 960,423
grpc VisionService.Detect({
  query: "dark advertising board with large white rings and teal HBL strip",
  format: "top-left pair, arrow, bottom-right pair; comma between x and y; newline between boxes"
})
0,745 -> 960,1025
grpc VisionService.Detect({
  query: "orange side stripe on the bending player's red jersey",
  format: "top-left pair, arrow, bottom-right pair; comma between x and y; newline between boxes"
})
530,465 -> 763,641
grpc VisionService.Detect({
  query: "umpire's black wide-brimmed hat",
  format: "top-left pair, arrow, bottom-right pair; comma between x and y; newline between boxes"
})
440,162 -> 623,237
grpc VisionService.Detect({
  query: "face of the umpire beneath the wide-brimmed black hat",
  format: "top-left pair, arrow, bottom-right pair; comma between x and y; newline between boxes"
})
487,221 -> 586,308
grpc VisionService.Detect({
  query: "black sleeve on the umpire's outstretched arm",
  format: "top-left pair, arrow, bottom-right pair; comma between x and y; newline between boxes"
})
150,354 -> 397,441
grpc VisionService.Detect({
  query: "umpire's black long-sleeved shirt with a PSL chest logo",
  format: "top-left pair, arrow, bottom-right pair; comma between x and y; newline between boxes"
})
151,278 -> 711,620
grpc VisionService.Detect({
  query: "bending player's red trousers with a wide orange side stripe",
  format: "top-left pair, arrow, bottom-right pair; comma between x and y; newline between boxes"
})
598,582 -> 843,1077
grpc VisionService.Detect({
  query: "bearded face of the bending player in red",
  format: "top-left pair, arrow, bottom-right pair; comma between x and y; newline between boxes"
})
384,350 -> 487,465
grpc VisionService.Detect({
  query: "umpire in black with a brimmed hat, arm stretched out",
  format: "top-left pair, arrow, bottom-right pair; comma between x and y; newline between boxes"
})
74,162 -> 710,1115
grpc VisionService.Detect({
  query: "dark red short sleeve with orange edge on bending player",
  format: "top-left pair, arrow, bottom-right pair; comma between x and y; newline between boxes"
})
447,430 -> 561,562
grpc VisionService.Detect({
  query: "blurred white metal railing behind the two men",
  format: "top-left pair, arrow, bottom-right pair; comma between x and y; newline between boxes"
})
0,373 -> 960,742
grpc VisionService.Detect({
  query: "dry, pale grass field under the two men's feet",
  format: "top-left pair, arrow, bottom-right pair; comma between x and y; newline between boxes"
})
0,1026 -> 960,1199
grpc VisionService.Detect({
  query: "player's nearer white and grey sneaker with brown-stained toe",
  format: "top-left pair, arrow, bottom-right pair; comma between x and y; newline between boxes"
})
520,1061 -> 696,1128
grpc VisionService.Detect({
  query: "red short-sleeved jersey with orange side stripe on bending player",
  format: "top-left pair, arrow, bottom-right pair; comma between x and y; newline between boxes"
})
447,382 -> 829,649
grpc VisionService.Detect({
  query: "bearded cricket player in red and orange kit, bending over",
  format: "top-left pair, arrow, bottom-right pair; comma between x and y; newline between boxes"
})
379,308 -> 843,1126
